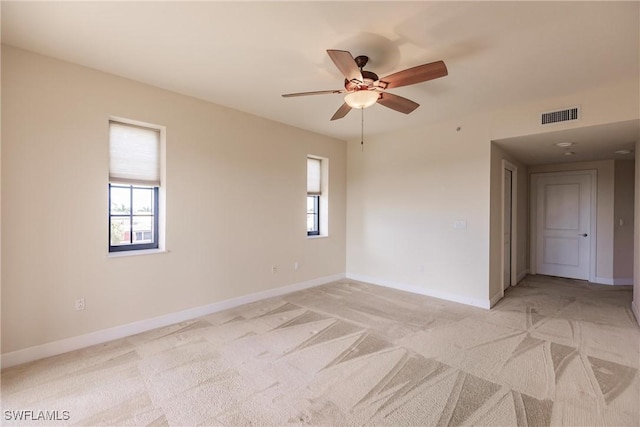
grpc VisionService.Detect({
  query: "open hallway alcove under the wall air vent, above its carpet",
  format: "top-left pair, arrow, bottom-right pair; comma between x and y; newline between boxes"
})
490,119 -> 640,310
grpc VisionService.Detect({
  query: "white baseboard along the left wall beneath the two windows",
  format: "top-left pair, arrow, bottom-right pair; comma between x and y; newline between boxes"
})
0,273 -> 346,369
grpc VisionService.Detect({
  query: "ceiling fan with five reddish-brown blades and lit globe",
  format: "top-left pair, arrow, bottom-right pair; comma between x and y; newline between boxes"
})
282,49 -> 448,120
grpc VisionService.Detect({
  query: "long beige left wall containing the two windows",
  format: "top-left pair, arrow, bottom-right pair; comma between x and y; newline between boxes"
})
2,47 -> 346,353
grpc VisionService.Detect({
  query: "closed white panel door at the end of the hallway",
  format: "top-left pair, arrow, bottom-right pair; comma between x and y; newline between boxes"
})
536,173 -> 594,280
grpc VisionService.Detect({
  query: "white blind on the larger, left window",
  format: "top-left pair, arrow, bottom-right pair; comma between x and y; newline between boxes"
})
109,121 -> 160,186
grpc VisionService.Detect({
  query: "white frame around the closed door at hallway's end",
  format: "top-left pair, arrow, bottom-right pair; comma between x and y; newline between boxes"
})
529,169 -> 598,283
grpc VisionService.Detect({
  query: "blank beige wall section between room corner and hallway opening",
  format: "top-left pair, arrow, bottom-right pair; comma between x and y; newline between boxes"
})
347,116 -> 490,302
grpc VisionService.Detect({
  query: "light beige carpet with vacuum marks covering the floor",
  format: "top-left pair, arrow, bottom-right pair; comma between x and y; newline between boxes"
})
2,276 -> 640,426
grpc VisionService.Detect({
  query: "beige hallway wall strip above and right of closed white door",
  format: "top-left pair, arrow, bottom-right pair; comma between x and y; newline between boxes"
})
529,160 -> 614,280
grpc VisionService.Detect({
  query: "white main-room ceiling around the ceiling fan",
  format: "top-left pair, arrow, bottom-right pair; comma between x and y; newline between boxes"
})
2,0 -> 640,165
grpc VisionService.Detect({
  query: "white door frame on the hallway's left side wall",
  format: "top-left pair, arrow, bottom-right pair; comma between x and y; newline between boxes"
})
500,159 -> 518,297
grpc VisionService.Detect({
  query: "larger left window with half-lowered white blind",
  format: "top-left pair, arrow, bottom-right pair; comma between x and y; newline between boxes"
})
109,121 -> 160,252
